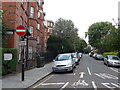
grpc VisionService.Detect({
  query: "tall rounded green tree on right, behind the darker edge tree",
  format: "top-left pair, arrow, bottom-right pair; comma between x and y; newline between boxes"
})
87,22 -> 115,51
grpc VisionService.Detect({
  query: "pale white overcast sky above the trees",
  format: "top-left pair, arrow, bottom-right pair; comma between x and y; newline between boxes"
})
43,0 -> 120,42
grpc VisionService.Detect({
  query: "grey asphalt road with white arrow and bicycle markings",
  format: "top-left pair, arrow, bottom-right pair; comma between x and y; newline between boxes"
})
28,54 -> 120,90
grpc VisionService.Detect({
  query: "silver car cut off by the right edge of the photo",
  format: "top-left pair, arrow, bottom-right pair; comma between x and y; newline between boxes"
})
104,55 -> 120,66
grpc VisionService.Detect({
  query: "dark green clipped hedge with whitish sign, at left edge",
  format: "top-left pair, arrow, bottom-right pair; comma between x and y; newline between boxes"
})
0,48 -> 18,75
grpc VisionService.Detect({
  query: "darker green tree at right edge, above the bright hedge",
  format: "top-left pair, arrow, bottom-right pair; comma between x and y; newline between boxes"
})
101,29 -> 120,51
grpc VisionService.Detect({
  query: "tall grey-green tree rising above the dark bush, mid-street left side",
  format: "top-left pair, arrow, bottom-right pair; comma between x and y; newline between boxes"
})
54,18 -> 86,51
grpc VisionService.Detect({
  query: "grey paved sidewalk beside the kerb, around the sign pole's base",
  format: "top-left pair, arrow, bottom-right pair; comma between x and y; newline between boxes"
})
0,63 -> 53,90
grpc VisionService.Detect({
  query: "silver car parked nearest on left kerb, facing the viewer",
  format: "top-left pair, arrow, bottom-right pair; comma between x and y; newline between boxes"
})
52,53 -> 75,72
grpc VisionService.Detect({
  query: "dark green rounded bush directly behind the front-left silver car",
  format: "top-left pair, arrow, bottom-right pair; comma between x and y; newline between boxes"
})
47,36 -> 73,54
